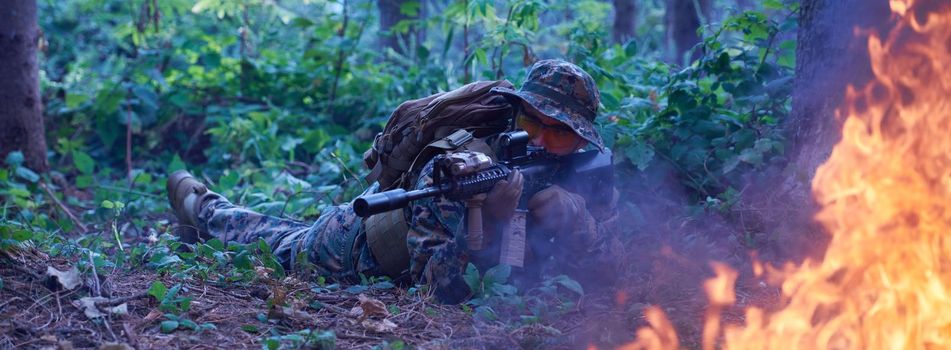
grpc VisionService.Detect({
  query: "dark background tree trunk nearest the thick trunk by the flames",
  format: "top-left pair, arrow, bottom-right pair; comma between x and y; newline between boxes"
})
664,0 -> 710,63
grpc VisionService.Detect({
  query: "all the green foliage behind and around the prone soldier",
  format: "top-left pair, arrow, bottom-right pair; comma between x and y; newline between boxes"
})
0,0 -> 798,342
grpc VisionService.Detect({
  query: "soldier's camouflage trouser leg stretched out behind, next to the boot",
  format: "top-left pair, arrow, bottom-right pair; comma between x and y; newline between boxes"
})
198,198 -> 380,280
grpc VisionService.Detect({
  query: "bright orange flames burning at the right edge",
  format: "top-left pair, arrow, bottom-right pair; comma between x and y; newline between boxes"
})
624,0 -> 951,349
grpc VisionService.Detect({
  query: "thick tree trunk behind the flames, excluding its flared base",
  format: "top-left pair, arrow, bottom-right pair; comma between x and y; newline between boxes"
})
785,0 -> 890,174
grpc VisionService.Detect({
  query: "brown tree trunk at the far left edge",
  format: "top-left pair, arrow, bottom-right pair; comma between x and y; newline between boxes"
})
0,0 -> 48,171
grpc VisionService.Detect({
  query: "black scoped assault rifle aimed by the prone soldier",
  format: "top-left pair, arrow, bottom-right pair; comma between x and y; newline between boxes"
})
353,130 -> 614,217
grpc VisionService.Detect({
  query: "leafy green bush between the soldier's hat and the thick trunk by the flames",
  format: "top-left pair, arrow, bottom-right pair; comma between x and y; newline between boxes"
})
600,8 -> 795,203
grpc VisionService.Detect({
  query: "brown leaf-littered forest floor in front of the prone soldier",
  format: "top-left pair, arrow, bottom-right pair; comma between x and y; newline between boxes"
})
0,182 -> 812,349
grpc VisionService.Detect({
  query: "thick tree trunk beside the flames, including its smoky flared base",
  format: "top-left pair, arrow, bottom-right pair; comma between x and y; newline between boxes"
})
750,0 -> 890,261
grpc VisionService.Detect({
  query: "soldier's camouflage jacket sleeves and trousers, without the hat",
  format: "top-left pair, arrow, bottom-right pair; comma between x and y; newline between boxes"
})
198,154 -> 619,303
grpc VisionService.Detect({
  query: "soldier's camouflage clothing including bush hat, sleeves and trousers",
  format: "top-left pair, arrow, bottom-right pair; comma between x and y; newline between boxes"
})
198,60 -> 620,303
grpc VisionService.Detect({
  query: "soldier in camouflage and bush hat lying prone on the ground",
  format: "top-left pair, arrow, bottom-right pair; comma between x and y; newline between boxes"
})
167,60 -> 620,303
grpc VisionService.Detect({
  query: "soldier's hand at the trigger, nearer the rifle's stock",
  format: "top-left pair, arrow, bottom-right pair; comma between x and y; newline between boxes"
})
528,185 -> 588,235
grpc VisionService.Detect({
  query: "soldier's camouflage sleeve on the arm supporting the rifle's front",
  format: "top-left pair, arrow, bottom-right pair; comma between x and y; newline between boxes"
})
406,161 -> 471,304
